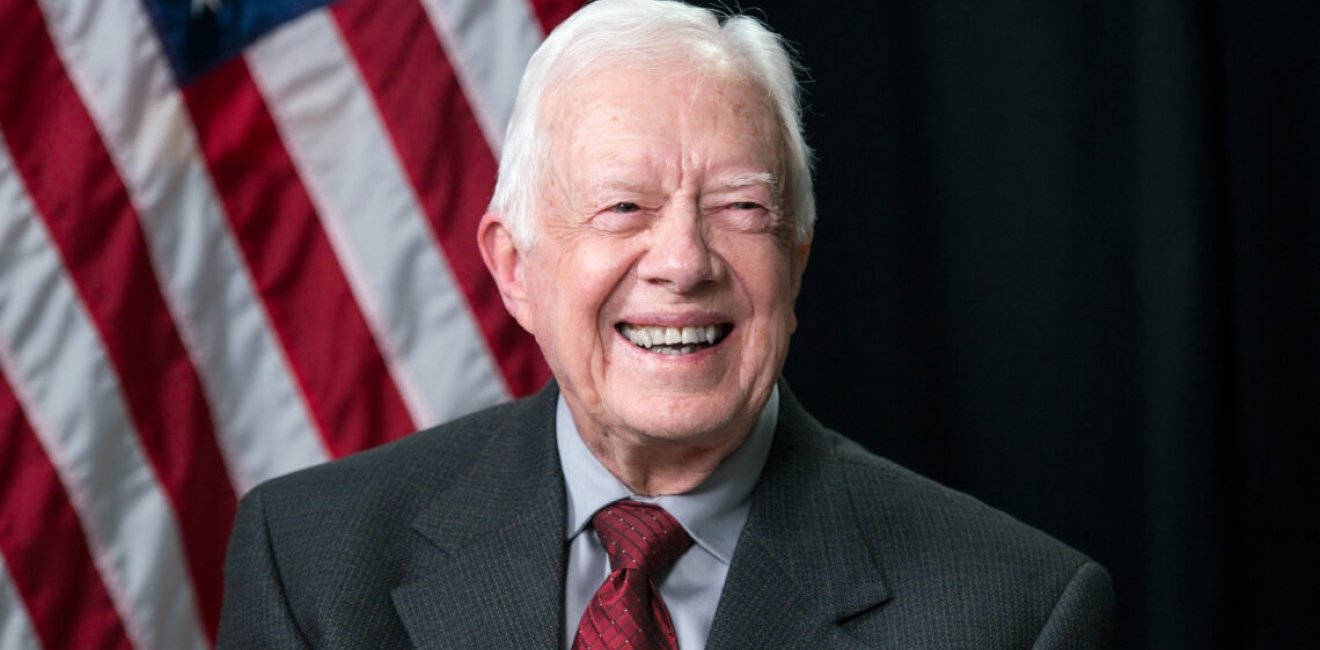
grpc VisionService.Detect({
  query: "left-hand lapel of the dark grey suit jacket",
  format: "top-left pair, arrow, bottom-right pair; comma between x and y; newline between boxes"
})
393,388 -> 565,647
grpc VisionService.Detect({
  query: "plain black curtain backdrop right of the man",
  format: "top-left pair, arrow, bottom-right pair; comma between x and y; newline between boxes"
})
691,0 -> 1320,649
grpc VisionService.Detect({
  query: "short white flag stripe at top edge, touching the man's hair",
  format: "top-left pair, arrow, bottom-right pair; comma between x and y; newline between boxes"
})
422,0 -> 544,153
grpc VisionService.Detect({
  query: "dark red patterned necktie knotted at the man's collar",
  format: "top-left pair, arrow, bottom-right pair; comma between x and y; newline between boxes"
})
573,501 -> 692,650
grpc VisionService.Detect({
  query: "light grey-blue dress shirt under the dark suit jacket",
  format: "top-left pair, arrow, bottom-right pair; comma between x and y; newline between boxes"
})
554,386 -> 779,650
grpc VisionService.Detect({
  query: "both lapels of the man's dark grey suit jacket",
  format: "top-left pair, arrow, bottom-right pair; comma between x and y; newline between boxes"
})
393,380 -> 890,649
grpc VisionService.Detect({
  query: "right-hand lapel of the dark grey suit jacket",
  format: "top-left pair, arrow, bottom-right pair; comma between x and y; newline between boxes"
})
708,382 -> 890,649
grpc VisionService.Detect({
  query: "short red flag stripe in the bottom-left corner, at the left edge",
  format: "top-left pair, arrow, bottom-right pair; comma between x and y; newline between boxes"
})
0,373 -> 132,649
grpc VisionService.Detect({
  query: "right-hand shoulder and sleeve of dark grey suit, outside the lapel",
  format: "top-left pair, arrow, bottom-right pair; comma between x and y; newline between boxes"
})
830,432 -> 1113,647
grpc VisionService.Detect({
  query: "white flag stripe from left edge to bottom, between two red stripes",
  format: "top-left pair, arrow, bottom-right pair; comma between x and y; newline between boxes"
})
0,141 -> 207,649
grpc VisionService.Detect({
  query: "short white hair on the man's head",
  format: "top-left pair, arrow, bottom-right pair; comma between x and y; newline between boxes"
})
490,0 -> 816,246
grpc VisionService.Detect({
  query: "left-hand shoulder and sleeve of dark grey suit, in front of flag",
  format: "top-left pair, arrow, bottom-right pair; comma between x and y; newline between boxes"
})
226,391 -> 557,647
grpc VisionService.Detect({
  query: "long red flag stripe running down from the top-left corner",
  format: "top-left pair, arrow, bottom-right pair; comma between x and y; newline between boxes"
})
0,0 -> 238,639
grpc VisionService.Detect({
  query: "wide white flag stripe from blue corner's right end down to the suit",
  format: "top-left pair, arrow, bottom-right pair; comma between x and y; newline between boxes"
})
248,11 -> 508,425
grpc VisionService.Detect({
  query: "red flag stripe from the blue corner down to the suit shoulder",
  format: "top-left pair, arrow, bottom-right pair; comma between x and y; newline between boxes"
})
183,58 -> 417,456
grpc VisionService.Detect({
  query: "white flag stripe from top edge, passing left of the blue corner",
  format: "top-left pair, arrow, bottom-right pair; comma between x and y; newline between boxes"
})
41,0 -> 329,494
